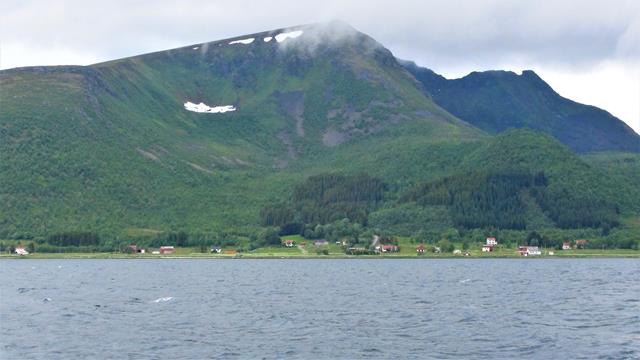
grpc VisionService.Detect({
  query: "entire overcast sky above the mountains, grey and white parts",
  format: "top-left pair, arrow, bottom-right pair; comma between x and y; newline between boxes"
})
0,0 -> 640,132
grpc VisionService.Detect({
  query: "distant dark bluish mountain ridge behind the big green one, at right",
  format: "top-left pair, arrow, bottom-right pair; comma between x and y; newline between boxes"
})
402,61 -> 640,153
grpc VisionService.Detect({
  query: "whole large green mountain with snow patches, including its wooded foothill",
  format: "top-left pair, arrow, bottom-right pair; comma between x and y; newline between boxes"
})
0,22 -> 640,248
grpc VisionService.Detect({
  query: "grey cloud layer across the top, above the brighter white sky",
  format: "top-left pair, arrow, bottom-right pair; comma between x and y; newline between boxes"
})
0,0 -> 640,67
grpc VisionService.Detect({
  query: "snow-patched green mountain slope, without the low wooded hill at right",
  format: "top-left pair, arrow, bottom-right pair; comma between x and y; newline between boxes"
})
0,24 -> 484,236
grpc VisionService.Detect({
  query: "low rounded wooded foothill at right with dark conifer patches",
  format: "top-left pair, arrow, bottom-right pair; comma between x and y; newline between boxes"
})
262,130 -> 640,235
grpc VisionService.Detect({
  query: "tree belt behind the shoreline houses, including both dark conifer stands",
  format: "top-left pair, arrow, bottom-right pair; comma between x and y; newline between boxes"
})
0,171 -> 638,252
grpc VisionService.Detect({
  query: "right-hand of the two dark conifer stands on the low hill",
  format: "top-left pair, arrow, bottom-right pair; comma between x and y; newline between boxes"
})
403,172 -> 619,230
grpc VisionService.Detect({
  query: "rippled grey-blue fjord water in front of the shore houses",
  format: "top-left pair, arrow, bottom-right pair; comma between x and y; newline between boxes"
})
0,259 -> 640,359
